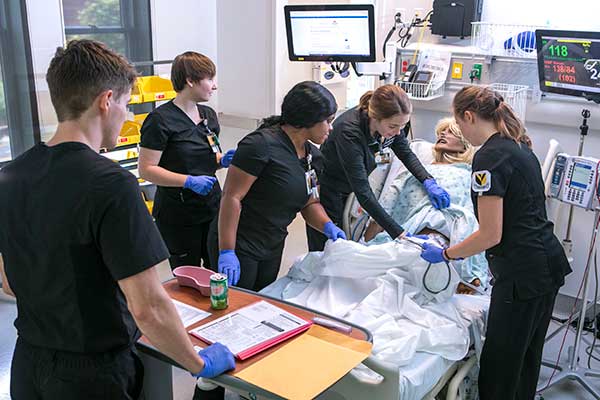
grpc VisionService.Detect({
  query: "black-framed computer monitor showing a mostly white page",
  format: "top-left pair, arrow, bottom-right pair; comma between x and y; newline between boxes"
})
284,4 -> 375,62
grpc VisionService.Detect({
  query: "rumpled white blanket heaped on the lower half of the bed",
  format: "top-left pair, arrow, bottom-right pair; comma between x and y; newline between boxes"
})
263,240 -> 485,366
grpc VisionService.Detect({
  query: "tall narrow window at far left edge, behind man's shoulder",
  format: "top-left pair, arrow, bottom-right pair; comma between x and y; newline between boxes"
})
0,0 -> 40,166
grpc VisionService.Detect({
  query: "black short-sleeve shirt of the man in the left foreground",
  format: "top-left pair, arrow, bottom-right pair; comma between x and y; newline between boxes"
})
0,142 -> 169,353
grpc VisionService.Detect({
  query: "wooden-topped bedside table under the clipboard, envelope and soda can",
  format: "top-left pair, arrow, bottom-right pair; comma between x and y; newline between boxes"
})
137,279 -> 373,400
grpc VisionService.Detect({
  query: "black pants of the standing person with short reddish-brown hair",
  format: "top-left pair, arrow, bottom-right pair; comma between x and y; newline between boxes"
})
156,218 -> 212,269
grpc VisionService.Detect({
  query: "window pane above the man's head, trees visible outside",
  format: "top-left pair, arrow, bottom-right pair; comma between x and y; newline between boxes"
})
62,0 -> 152,62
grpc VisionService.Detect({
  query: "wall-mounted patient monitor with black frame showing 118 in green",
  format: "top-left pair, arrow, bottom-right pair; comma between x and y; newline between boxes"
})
535,29 -> 600,99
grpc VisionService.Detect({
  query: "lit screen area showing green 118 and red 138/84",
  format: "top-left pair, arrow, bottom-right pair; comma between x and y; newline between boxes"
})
541,36 -> 600,93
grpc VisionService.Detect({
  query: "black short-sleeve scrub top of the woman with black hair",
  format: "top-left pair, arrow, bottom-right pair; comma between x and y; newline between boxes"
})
232,125 -> 309,259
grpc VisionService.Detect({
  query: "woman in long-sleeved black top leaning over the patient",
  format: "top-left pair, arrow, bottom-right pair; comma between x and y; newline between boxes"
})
308,85 -> 450,251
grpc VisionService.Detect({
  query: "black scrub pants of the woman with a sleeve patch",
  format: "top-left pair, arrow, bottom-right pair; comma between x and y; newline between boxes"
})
479,283 -> 558,400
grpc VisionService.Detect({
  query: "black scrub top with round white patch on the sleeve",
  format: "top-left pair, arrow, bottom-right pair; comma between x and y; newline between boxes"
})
471,133 -> 571,299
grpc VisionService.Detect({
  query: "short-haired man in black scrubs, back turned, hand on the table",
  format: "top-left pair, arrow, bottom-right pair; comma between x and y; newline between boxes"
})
0,40 -> 235,400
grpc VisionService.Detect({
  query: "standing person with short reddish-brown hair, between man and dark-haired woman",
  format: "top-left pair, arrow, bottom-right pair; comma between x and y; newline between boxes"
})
139,51 -> 235,268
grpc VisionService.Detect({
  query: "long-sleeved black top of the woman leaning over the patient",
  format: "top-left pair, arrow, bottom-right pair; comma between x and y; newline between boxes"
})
321,107 -> 431,238
